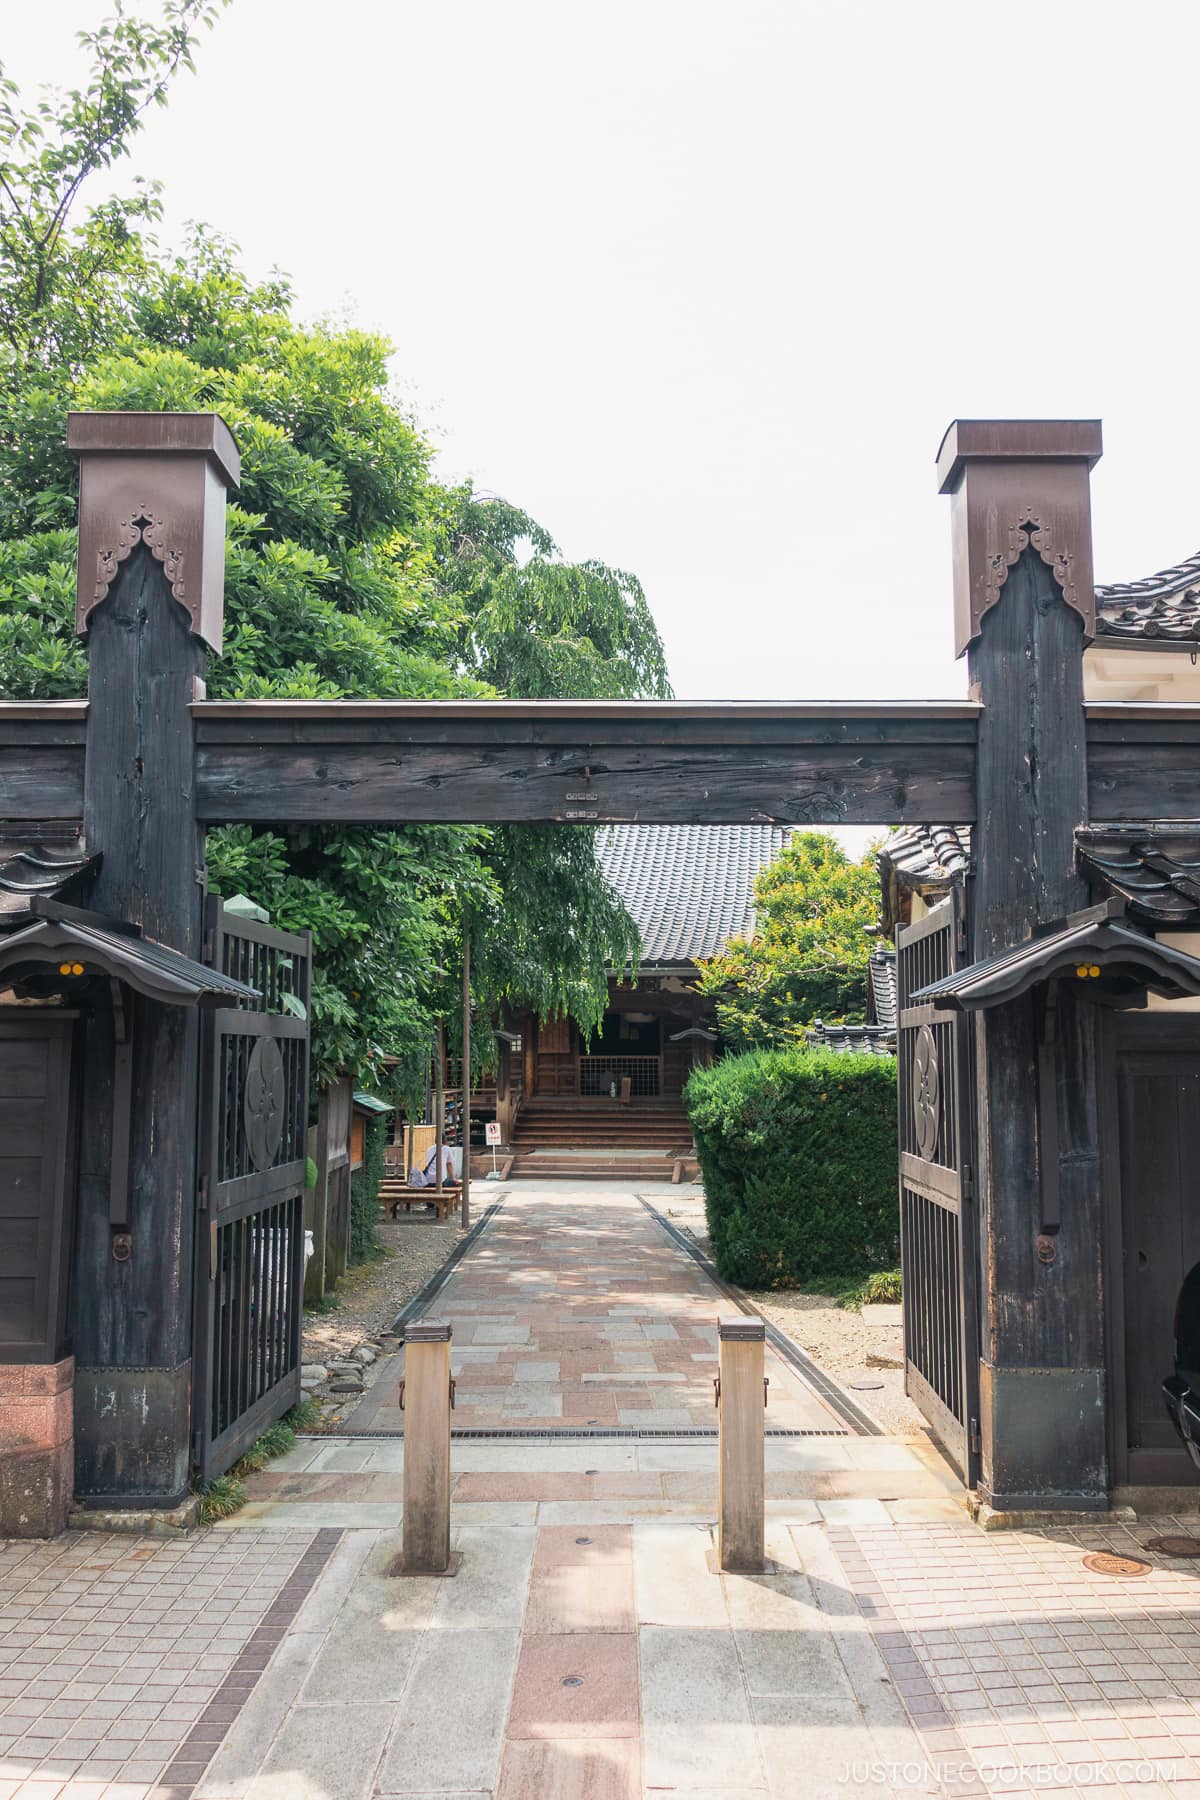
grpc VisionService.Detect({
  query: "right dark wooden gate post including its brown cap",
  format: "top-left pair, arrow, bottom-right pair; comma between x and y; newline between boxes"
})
937,419 -> 1108,1510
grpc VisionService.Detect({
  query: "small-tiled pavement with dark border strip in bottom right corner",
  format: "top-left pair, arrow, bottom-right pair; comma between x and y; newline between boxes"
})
829,1516 -> 1200,1800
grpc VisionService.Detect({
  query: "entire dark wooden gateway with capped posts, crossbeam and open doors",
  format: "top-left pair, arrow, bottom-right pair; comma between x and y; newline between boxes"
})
0,414 -> 1200,1532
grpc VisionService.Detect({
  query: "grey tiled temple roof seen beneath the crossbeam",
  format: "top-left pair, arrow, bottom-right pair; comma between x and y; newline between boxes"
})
596,824 -> 792,967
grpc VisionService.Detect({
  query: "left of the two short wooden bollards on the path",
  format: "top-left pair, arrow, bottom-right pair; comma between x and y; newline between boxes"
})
399,1319 -> 452,1575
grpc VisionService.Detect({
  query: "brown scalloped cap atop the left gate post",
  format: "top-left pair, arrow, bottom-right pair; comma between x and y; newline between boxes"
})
67,412 -> 241,652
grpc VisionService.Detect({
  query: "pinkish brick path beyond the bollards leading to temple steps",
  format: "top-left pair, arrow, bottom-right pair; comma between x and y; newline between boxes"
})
353,1188 -> 846,1431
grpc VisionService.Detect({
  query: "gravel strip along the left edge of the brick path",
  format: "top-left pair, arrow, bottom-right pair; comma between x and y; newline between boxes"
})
304,1208 -> 475,1363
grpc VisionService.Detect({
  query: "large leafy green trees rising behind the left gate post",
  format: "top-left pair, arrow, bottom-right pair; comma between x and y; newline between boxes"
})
0,10 -> 669,1075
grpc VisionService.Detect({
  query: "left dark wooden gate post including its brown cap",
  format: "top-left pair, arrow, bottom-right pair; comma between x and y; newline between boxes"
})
68,412 -> 239,1507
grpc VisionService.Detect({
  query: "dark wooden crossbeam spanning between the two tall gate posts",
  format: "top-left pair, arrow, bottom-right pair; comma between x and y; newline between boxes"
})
194,700 -> 979,824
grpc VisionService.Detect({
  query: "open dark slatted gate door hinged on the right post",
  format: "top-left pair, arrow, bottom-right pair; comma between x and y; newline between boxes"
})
896,887 -> 979,1487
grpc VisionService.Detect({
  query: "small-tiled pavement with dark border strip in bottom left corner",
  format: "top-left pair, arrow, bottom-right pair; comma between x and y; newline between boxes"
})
0,1532 -> 342,1800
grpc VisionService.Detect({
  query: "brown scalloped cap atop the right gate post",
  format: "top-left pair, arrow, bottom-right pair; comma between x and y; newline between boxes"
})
937,419 -> 1101,655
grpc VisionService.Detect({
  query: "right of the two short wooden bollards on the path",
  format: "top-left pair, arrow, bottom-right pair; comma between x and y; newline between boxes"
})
716,1318 -> 766,1571
